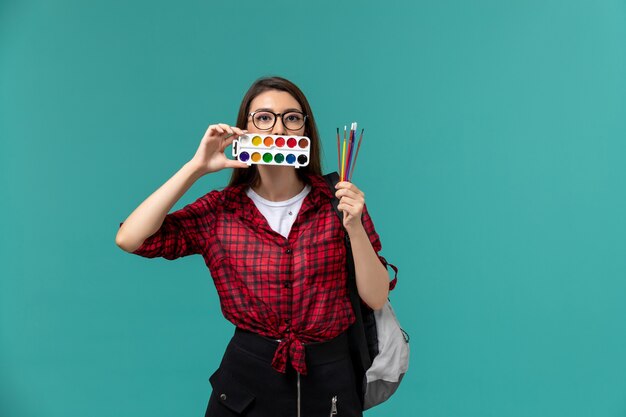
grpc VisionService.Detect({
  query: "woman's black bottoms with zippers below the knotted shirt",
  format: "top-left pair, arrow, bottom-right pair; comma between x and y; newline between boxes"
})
205,329 -> 363,417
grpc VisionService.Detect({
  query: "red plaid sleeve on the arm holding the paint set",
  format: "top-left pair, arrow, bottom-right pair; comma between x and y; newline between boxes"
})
119,192 -> 216,260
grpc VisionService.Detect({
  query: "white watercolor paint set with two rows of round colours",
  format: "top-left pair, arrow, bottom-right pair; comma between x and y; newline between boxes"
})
232,133 -> 311,168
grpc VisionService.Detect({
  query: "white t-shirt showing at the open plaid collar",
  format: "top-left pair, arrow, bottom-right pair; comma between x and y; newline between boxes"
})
246,184 -> 311,238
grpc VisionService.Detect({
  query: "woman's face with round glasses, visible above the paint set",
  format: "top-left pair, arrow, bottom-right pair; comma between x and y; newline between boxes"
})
246,90 -> 305,136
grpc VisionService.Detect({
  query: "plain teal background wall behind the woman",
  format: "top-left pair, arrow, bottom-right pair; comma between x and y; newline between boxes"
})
0,0 -> 626,417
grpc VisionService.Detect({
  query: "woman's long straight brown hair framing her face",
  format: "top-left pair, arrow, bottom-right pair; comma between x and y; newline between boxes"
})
228,77 -> 322,186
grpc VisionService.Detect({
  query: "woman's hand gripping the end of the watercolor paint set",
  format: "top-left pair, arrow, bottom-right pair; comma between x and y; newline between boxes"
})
190,123 -> 248,175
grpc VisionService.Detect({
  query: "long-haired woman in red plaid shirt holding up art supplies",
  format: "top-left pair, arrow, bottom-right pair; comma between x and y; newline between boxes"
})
116,77 -> 390,417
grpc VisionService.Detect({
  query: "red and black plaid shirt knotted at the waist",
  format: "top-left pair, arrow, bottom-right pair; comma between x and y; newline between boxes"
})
120,175 -> 396,374
